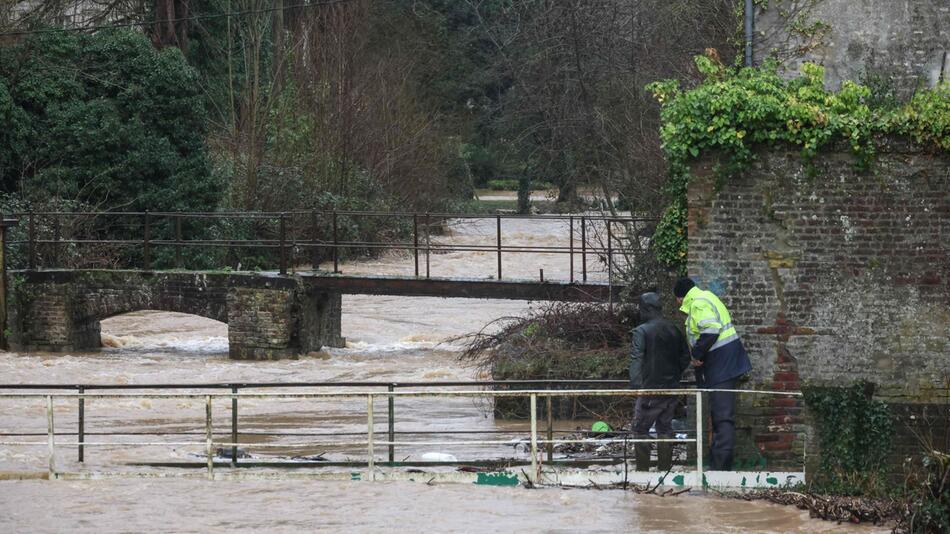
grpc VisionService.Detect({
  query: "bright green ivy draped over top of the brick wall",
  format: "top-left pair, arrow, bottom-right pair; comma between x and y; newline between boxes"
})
647,56 -> 950,269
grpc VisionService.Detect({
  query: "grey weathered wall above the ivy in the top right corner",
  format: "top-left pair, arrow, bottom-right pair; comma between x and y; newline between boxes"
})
755,0 -> 950,97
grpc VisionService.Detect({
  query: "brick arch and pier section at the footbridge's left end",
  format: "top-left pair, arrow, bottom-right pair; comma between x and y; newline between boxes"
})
7,270 -> 343,359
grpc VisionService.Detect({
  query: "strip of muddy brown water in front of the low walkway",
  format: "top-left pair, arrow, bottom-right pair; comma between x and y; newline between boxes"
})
0,480 -> 875,533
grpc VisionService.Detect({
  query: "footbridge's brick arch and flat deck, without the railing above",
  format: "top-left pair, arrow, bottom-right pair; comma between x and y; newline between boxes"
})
4,269 -> 622,359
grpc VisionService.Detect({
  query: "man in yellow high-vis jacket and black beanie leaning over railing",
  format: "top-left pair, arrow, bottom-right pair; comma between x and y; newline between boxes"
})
673,278 -> 752,471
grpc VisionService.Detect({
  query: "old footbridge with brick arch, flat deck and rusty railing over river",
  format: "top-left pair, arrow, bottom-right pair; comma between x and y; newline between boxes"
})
0,211 -> 651,359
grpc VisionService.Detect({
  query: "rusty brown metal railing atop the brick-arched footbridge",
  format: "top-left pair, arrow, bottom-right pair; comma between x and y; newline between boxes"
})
8,210 -> 655,283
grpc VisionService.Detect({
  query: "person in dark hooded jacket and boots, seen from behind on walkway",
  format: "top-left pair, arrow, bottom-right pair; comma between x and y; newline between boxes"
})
630,293 -> 689,471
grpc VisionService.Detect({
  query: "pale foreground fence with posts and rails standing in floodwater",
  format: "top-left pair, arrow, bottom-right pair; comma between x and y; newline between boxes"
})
0,381 -> 801,482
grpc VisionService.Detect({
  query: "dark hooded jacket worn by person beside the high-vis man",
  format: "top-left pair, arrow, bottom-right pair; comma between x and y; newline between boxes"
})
630,293 -> 689,389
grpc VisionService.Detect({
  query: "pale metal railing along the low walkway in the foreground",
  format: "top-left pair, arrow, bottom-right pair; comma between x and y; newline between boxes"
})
0,384 -> 801,482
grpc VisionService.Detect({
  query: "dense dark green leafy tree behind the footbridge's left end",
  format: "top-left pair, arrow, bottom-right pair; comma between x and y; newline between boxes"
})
0,30 -> 221,210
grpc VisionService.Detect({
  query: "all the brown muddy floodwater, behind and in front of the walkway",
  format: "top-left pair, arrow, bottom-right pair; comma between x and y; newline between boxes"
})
0,216 -> 873,532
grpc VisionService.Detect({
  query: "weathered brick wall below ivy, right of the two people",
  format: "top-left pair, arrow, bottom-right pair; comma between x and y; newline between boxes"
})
688,143 -> 950,465
